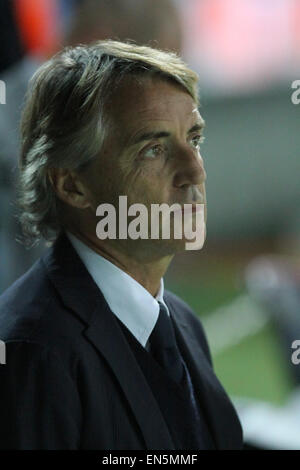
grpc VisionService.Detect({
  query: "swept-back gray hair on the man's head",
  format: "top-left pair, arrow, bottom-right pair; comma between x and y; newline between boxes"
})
18,40 -> 198,246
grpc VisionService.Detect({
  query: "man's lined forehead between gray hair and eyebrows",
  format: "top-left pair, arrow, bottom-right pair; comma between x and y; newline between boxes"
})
109,77 -> 202,140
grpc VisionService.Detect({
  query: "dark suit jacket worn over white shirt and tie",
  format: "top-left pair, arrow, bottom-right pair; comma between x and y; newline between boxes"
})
0,235 -> 242,450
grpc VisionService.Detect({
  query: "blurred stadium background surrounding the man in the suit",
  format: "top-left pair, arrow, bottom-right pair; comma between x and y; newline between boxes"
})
0,0 -> 300,449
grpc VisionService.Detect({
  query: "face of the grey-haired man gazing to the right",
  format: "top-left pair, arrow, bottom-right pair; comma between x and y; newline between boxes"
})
81,78 -> 206,256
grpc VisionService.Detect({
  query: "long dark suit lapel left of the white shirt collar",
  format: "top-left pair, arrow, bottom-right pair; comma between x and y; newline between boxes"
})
43,236 -> 174,449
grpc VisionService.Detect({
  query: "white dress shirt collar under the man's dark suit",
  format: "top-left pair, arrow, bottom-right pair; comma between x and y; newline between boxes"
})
67,232 -> 170,350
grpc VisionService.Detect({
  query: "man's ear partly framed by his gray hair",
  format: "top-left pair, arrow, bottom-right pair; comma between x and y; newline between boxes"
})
48,168 -> 90,209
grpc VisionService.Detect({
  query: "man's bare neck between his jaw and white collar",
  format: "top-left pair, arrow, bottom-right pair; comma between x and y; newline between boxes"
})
68,228 -> 173,297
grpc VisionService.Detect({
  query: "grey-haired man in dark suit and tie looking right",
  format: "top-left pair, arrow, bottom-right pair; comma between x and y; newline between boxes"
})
0,41 -> 242,450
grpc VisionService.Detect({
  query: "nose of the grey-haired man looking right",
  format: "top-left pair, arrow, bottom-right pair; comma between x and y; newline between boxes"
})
173,145 -> 206,189
